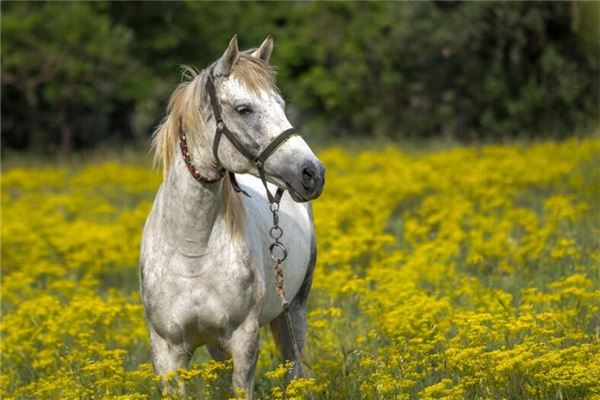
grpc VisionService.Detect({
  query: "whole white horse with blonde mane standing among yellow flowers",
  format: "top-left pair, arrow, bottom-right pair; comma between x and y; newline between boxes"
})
140,36 -> 325,398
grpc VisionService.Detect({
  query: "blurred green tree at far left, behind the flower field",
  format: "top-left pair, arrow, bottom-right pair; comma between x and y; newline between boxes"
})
2,2 -> 152,155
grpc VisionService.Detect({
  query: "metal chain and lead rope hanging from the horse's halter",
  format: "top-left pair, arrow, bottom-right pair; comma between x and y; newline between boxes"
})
269,201 -> 305,377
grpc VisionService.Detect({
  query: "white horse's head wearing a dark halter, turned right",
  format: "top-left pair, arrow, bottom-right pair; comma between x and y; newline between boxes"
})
207,36 -> 325,202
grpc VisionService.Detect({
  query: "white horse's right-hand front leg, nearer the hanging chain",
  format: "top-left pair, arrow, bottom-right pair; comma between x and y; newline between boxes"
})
229,317 -> 259,400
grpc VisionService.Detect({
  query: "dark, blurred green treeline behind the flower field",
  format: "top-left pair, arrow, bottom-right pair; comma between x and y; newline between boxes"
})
1,2 -> 599,153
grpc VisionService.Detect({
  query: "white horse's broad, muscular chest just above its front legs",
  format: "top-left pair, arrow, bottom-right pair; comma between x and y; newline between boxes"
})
143,253 -> 264,346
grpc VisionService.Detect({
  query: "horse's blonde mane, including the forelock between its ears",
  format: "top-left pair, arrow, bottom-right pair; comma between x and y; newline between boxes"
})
152,52 -> 277,234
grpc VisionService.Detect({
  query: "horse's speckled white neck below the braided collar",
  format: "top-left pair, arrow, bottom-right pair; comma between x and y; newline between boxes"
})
163,153 -> 223,255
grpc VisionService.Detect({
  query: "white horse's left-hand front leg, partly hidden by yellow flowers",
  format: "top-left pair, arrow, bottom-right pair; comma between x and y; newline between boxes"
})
150,327 -> 191,396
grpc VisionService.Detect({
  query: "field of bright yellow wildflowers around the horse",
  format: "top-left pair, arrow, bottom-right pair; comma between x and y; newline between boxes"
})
0,139 -> 600,399
